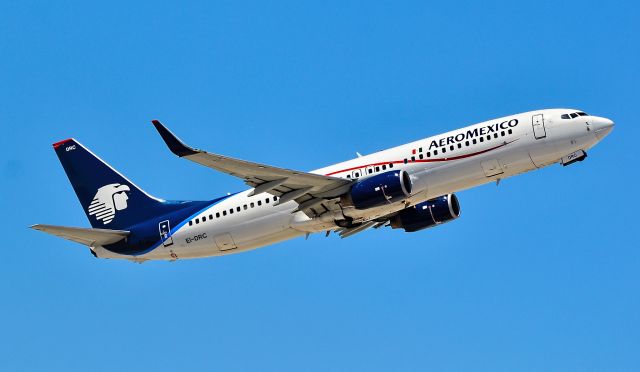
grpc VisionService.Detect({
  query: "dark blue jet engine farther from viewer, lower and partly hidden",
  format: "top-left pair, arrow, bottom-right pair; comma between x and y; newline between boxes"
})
391,194 -> 460,232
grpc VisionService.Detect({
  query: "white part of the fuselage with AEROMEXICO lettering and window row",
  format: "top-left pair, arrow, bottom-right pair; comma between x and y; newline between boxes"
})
94,109 -> 612,261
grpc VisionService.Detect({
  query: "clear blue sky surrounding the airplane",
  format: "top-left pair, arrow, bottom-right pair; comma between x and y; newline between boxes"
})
0,1 -> 640,371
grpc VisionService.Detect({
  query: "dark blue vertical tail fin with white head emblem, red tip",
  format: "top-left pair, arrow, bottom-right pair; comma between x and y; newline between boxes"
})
53,138 -> 168,230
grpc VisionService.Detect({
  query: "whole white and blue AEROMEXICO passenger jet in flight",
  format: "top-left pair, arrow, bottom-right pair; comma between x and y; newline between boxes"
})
32,109 -> 613,262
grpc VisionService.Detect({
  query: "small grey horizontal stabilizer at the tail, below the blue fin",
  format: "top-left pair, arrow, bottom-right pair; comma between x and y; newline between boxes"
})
31,225 -> 129,247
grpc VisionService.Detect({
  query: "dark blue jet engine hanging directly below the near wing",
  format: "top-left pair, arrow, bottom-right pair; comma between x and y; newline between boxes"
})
341,170 -> 411,209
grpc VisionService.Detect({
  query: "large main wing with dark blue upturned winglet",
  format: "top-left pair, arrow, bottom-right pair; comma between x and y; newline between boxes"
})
152,120 -> 353,217
